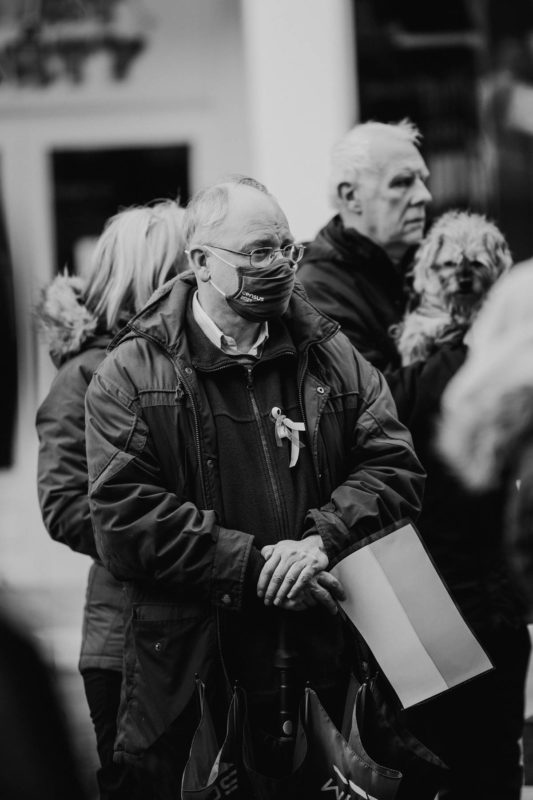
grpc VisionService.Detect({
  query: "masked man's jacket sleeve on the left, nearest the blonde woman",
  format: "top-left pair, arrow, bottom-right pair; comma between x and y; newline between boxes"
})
86,351 -> 263,609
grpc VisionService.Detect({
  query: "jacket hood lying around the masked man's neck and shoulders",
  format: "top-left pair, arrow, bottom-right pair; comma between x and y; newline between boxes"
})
118,271 -> 339,354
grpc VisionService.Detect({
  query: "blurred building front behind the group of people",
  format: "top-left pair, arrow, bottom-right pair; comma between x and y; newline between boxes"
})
0,0 -> 533,792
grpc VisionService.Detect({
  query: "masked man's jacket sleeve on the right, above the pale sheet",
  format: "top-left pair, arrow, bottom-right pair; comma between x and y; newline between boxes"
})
304,353 -> 425,563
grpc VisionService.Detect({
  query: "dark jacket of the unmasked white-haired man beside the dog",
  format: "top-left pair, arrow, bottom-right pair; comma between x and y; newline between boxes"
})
298,215 -> 409,371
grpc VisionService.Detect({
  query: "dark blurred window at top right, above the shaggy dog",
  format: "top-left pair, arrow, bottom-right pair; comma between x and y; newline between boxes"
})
354,0 -> 533,260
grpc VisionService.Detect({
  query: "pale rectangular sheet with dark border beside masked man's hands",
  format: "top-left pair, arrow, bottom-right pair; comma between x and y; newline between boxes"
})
331,521 -> 492,708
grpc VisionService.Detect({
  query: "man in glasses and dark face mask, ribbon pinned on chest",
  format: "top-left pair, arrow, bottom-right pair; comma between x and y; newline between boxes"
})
87,178 -> 423,800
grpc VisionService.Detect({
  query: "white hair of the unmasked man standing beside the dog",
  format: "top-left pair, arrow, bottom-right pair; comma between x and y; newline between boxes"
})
329,119 -> 422,208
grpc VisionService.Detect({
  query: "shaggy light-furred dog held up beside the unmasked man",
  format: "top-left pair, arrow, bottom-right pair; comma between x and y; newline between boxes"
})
391,211 -> 512,366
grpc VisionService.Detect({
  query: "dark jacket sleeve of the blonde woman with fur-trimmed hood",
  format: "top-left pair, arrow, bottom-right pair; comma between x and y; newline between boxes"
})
36,358 -> 98,558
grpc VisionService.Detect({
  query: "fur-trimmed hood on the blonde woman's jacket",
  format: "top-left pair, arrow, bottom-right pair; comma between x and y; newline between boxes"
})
35,275 -> 98,366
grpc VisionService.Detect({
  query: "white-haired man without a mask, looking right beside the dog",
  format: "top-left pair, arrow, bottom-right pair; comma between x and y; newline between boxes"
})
298,120 -> 431,370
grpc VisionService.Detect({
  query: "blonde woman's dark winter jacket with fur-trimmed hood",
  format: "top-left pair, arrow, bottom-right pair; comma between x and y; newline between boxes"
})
36,276 -> 124,671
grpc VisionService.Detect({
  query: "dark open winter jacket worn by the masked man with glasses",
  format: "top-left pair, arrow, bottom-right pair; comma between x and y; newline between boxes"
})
83,273 -> 423,755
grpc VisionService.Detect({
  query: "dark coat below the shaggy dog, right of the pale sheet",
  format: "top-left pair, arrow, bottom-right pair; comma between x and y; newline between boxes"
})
387,341 -> 523,641
